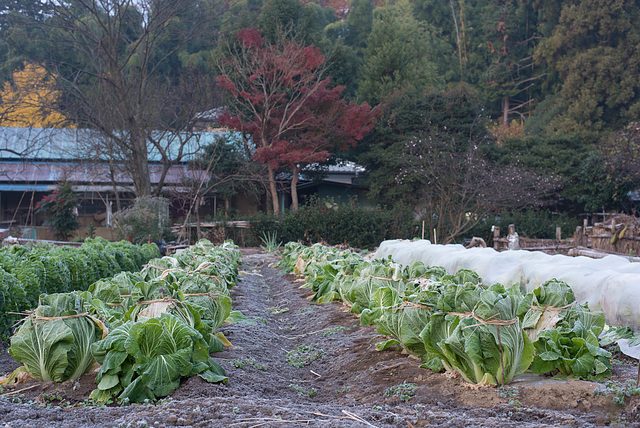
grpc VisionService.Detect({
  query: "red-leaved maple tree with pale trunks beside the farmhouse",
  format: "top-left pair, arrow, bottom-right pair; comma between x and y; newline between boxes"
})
217,28 -> 377,213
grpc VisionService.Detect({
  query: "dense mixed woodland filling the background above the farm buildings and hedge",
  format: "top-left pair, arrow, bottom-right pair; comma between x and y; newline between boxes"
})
0,0 -> 640,226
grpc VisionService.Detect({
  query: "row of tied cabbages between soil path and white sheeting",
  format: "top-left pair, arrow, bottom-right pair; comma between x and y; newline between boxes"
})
281,243 -> 612,385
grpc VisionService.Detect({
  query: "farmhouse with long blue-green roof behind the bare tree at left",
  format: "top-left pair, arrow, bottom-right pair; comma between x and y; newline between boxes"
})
0,127 -> 230,239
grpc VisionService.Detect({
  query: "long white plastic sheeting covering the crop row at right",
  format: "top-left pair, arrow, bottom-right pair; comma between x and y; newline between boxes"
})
374,240 -> 640,332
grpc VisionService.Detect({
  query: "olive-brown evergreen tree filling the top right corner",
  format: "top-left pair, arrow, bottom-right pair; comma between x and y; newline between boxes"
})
536,0 -> 640,136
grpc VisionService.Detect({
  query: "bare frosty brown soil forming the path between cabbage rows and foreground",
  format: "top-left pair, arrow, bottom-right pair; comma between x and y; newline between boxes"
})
0,250 -> 640,428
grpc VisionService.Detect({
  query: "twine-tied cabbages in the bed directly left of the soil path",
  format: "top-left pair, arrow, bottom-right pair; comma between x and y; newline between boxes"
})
9,240 -> 241,403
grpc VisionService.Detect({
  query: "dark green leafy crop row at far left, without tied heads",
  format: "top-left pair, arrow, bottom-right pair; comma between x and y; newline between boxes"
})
0,238 -> 160,340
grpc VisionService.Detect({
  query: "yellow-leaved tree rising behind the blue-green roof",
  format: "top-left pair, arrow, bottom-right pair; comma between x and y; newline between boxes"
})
0,63 -> 74,128
